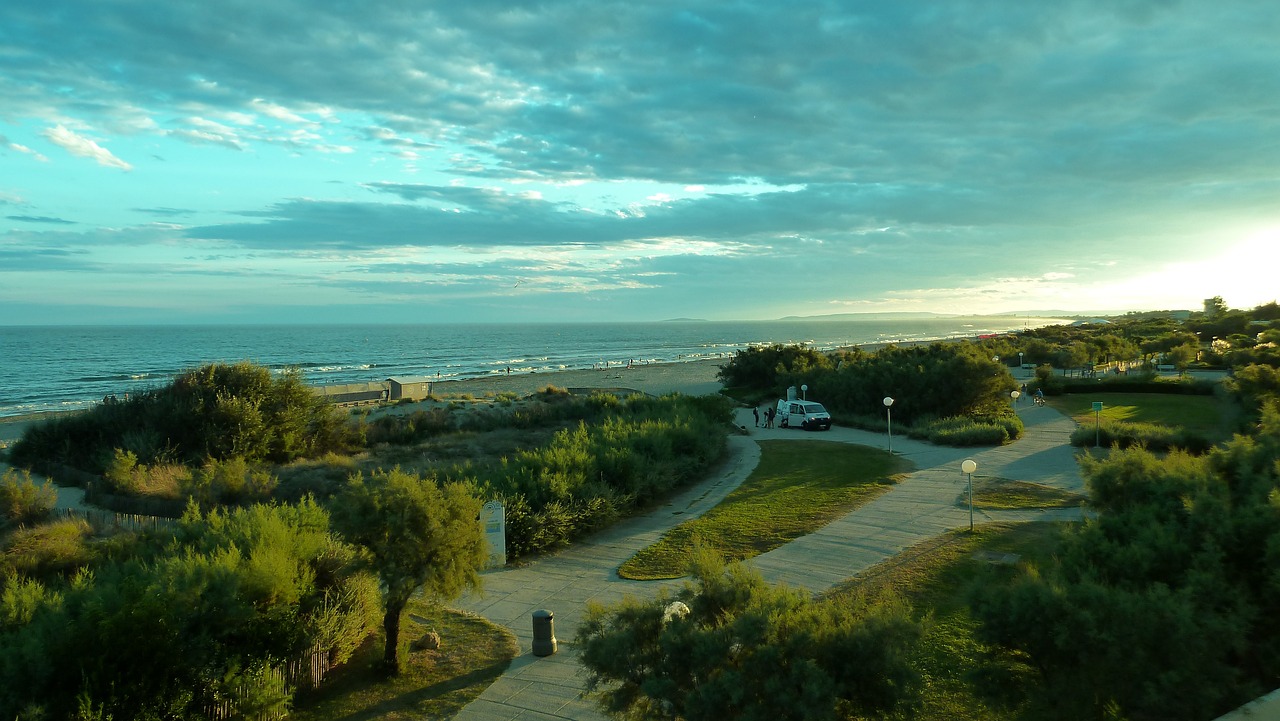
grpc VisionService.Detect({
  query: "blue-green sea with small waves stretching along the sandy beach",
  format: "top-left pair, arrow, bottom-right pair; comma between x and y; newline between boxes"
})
0,315 -> 1064,417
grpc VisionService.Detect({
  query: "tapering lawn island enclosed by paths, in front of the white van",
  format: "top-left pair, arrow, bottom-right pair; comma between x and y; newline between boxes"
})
618,441 -> 910,580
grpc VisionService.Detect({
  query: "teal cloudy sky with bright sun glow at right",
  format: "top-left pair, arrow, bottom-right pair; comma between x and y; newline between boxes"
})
0,0 -> 1280,324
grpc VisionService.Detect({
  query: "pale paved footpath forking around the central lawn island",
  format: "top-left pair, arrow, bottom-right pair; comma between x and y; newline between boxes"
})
454,405 -> 1084,721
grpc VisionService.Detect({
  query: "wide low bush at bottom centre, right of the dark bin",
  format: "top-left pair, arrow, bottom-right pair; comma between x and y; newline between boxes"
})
576,551 -> 919,721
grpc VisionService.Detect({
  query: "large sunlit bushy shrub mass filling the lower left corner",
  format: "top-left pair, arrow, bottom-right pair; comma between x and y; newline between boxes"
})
0,501 -> 379,718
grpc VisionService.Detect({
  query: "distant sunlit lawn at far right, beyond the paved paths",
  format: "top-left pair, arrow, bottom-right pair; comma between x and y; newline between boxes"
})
1048,393 -> 1231,441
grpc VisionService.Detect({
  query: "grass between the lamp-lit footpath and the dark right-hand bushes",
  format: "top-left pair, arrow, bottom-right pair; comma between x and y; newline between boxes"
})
824,524 -> 1060,721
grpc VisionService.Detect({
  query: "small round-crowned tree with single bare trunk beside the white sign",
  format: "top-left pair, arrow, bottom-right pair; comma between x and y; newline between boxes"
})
333,467 -> 488,675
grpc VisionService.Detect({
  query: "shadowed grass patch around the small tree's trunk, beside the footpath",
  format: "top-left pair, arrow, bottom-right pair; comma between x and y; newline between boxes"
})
289,601 -> 518,721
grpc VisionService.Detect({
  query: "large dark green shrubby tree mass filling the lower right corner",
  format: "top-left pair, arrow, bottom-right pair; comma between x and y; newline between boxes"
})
974,405 -> 1280,720
